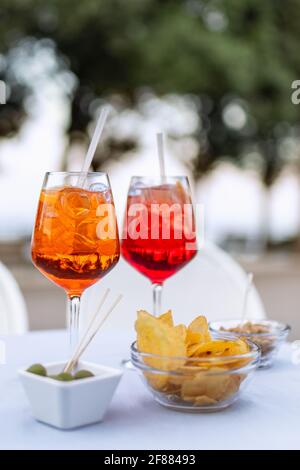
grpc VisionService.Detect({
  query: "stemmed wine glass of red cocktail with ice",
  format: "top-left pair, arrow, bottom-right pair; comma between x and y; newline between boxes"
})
121,176 -> 197,315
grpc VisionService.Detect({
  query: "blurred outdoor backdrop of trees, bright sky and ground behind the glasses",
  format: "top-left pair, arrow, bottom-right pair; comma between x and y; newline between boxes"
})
0,0 -> 300,335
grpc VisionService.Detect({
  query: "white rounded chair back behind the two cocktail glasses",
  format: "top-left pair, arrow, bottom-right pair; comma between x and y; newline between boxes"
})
82,243 -> 265,329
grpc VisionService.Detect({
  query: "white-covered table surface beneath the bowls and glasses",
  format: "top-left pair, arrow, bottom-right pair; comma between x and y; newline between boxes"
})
0,331 -> 300,450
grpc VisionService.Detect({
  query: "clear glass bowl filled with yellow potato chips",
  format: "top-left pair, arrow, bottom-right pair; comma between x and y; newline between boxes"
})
131,311 -> 260,412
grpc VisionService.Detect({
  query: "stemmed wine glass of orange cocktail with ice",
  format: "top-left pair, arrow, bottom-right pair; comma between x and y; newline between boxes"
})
32,172 -> 120,347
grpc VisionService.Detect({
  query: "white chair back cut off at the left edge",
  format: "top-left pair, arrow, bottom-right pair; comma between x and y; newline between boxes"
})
0,263 -> 28,335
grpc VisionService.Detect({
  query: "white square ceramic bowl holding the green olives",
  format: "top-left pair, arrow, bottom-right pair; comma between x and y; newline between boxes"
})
19,362 -> 122,429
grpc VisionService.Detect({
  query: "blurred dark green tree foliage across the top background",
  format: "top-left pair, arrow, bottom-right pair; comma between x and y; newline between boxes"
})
0,0 -> 300,186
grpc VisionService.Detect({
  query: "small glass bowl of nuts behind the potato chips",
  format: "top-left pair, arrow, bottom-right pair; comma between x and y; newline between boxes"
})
209,319 -> 291,368
